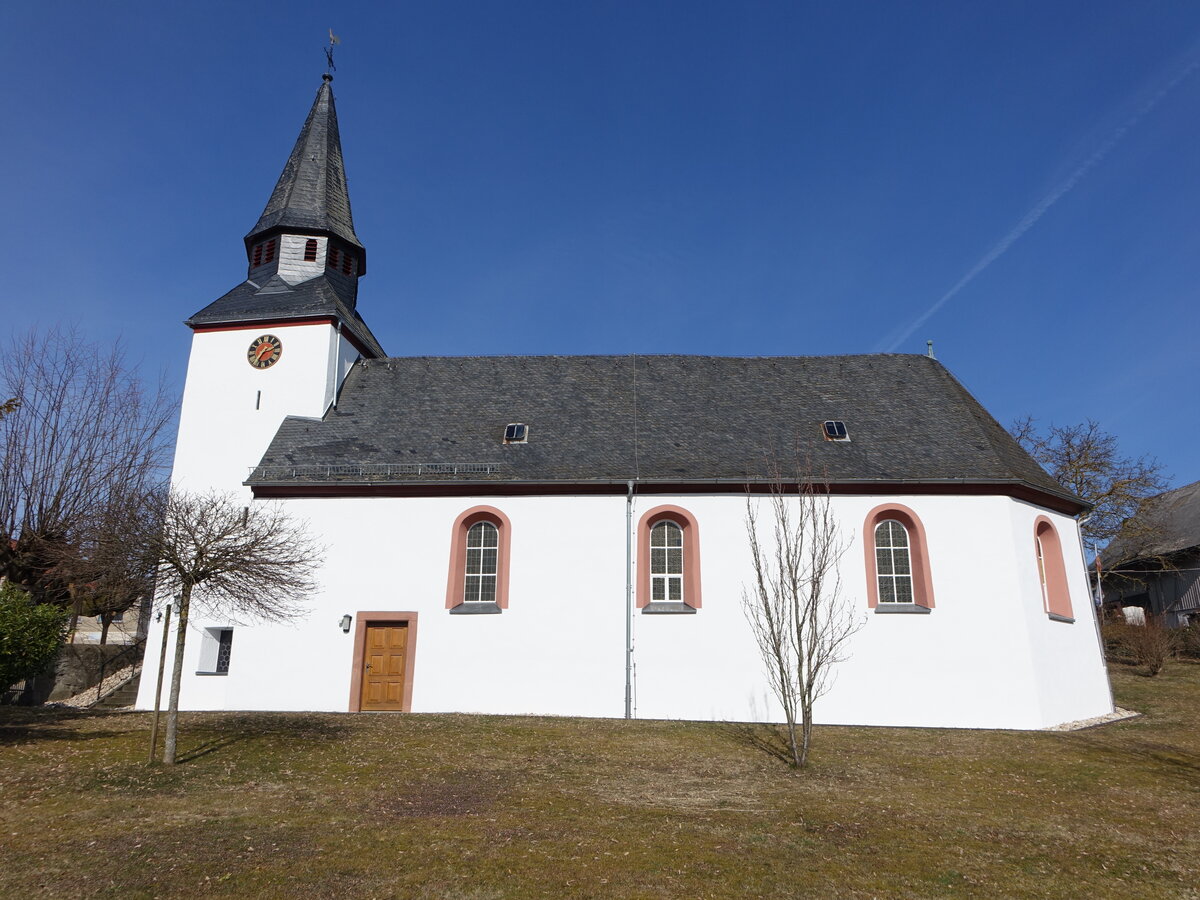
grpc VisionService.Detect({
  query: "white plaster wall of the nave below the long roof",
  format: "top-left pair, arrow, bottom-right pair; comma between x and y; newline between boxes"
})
139,496 -> 1111,728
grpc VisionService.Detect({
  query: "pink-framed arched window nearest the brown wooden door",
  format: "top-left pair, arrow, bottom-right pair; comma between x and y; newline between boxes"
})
446,506 -> 511,613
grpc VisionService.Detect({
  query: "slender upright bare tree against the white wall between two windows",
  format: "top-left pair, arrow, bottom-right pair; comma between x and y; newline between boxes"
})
742,476 -> 859,767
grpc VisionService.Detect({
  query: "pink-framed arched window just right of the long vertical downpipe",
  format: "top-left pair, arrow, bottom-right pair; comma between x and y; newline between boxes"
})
637,506 -> 700,613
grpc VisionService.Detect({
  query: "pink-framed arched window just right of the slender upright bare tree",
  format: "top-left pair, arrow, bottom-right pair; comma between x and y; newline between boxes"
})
863,503 -> 934,612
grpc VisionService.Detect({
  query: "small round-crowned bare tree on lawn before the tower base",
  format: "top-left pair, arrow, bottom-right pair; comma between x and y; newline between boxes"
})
154,492 -> 324,764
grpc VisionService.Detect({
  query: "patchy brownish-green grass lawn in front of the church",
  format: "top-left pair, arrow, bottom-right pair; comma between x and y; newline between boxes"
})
0,662 -> 1200,900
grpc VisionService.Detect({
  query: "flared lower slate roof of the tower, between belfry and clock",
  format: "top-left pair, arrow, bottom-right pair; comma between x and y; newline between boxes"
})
185,275 -> 384,356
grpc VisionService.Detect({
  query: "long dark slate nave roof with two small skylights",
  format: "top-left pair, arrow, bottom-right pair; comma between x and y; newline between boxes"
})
247,354 -> 1082,506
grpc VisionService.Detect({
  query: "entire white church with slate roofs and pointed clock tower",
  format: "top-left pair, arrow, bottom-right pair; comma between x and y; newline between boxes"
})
138,77 -> 1112,728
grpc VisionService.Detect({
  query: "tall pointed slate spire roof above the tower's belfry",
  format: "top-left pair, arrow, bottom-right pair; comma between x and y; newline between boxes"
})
246,78 -> 366,256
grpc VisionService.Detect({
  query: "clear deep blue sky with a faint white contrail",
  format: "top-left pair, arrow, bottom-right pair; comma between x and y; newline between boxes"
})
0,0 -> 1200,482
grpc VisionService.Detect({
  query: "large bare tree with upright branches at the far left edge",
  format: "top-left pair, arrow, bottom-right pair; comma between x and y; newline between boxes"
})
0,329 -> 174,602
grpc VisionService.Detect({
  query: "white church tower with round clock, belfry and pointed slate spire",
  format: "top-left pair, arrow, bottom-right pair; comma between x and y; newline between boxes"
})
172,74 -> 384,491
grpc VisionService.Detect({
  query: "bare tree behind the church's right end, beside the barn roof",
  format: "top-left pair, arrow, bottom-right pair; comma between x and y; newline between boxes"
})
1009,415 -> 1168,546
